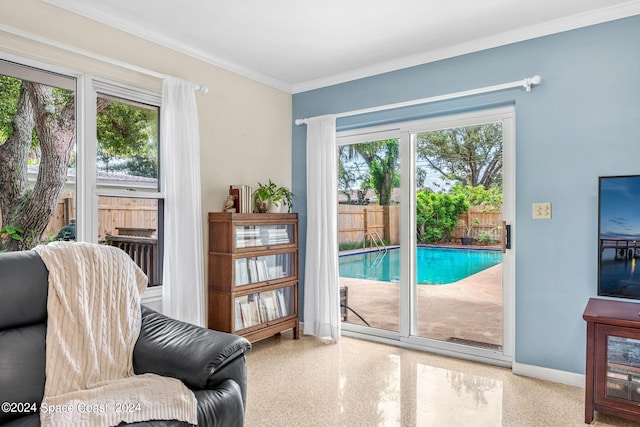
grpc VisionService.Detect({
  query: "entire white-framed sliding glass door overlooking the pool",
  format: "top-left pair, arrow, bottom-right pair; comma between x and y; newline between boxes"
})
338,107 -> 515,363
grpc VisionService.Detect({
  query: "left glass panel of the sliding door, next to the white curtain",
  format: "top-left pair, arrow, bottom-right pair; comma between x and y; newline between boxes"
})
338,135 -> 400,335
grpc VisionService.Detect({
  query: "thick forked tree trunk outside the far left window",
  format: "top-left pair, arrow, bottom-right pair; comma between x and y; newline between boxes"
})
0,81 -> 75,250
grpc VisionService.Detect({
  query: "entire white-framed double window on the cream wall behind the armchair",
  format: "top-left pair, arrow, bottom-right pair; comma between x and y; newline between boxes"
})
0,56 -> 164,286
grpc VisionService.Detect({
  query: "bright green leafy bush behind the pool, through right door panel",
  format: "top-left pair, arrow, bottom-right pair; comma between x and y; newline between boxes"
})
416,191 -> 469,243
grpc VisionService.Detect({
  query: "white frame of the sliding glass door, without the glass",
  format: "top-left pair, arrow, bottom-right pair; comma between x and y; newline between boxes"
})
336,105 -> 516,367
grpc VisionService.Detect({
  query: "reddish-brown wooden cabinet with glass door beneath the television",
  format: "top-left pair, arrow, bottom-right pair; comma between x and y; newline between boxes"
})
582,298 -> 640,424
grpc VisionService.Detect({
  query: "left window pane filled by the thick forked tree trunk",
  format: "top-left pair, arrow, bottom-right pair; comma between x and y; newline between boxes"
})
0,61 -> 77,251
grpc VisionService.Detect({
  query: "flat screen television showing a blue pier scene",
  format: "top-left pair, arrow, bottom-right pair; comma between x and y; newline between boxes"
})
598,175 -> 640,299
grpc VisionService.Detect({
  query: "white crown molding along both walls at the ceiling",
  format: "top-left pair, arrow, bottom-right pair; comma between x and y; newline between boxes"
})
42,0 -> 640,94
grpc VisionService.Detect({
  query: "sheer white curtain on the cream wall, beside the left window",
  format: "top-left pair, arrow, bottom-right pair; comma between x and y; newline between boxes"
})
160,76 -> 204,326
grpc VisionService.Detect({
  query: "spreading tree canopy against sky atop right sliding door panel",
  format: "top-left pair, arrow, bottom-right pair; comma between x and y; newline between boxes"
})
417,123 -> 502,189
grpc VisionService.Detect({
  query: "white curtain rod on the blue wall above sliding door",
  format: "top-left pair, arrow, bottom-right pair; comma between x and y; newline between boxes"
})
295,75 -> 542,126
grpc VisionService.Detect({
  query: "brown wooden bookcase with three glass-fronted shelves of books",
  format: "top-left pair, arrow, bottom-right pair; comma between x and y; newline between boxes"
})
207,212 -> 300,341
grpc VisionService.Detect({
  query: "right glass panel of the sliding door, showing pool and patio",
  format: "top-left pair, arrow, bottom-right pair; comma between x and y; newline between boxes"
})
412,121 -> 503,352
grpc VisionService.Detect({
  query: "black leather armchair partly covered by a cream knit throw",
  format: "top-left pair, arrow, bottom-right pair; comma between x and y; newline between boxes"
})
0,251 -> 251,427
